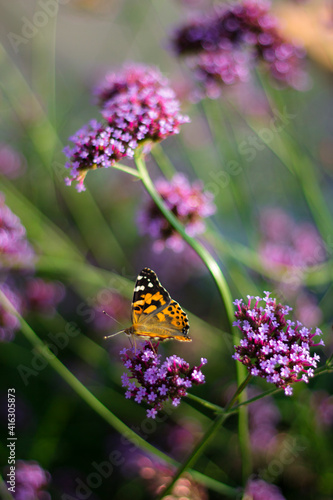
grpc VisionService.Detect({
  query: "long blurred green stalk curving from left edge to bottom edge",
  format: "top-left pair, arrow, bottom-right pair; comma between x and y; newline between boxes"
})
0,290 -> 236,496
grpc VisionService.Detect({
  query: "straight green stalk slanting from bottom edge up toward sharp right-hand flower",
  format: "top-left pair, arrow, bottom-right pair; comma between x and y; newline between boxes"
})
158,374 -> 252,500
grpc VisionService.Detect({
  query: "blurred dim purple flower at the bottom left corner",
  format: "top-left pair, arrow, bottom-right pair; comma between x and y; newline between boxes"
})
8,460 -> 51,500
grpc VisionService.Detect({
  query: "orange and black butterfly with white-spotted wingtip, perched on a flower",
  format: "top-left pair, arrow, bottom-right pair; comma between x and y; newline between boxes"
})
105,267 -> 192,342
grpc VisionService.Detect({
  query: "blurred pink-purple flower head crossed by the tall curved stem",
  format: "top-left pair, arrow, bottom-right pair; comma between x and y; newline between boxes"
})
138,174 -> 216,252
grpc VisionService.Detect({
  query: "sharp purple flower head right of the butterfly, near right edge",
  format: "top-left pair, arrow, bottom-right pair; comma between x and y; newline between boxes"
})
233,292 -> 324,396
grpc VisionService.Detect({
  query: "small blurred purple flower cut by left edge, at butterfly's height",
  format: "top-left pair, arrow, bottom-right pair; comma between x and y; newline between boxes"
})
0,283 -> 22,342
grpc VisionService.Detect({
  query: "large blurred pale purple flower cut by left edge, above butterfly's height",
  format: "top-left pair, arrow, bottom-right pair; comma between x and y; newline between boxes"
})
0,193 -> 35,269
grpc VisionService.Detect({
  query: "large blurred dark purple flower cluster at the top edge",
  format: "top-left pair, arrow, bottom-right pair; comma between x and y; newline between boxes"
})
172,0 -> 304,98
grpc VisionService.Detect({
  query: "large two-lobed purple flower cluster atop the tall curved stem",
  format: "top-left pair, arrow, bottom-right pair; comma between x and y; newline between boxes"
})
64,64 -> 189,191
